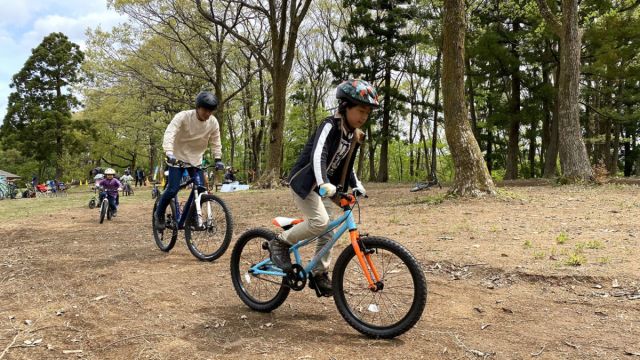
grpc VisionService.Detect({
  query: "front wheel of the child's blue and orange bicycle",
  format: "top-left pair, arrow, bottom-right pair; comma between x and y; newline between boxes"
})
333,237 -> 427,339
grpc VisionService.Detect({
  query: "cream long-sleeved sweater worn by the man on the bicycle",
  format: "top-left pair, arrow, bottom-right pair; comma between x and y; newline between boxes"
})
162,110 -> 222,165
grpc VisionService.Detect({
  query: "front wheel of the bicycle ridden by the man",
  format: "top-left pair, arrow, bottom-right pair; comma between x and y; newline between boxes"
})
184,194 -> 233,261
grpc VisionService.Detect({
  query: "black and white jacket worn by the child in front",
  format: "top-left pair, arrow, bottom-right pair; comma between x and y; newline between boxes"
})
289,116 -> 360,199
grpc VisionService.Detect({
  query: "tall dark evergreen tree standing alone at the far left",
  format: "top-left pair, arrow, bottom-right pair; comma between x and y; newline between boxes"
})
2,33 -> 84,179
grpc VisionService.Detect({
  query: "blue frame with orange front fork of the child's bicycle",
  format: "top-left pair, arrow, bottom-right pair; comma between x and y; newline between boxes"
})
249,194 -> 380,289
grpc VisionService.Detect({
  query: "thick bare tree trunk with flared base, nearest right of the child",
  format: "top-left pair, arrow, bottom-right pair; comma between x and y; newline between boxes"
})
442,0 -> 496,196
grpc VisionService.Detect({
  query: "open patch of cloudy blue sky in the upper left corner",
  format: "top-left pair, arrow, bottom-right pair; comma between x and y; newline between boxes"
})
0,0 -> 124,121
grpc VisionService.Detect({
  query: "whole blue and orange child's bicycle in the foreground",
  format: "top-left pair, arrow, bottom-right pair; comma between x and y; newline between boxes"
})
231,193 -> 427,338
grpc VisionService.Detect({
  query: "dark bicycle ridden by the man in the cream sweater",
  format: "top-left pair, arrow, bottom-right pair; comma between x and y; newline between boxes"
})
151,162 -> 233,261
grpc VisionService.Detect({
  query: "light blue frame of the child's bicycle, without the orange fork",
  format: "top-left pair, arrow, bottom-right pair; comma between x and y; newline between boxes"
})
249,209 -> 358,277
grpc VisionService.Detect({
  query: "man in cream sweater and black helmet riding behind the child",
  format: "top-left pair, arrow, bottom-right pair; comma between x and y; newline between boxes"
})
153,91 -> 224,231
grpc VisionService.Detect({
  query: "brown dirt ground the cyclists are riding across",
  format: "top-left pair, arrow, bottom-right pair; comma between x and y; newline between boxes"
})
0,184 -> 640,359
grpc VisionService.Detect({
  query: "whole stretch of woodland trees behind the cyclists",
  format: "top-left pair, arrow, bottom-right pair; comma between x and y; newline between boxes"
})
0,0 -> 640,193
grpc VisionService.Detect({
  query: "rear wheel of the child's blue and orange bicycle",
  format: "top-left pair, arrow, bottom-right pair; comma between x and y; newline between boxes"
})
231,228 -> 291,312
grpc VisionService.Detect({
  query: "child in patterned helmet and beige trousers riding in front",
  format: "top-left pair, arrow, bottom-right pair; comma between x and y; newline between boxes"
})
269,79 -> 379,296
